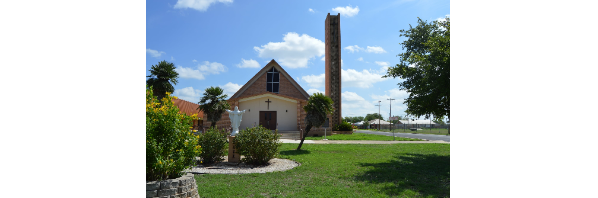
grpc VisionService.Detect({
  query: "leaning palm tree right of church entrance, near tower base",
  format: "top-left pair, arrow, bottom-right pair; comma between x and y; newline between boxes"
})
297,93 -> 334,150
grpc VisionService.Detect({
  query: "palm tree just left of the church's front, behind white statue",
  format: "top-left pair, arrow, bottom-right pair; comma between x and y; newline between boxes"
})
197,87 -> 230,128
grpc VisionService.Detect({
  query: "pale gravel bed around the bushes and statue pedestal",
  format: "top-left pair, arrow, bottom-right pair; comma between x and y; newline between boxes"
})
185,156 -> 301,174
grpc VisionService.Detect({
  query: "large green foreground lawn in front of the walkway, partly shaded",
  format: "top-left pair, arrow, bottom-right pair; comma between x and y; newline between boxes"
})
195,144 -> 450,197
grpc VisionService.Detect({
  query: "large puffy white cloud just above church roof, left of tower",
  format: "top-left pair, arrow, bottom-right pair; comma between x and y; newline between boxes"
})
253,32 -> 325,68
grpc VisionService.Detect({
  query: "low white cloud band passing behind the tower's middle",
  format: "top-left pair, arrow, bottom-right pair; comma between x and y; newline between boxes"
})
301,69 -> 388,88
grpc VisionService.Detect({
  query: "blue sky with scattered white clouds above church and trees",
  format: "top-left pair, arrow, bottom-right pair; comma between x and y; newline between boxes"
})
145,0 -> 450,123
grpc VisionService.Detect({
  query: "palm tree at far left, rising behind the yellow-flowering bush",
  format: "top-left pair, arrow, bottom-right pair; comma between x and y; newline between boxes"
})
145,60 -> 179,101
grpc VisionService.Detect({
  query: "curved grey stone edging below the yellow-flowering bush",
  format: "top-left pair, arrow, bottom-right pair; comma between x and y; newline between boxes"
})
145,173 -> 199,198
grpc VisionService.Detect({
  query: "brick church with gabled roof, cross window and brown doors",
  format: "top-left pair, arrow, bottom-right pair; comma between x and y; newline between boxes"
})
204,59 -> 309,131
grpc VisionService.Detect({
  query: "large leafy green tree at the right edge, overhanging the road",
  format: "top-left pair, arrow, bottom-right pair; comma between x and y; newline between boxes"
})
382,17 -> 451,119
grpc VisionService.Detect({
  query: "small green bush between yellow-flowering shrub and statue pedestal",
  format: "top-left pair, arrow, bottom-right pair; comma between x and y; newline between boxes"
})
198,128 -> 227,164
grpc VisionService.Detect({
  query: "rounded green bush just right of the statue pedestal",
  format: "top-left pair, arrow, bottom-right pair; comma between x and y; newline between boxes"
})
235,126 -> 282,165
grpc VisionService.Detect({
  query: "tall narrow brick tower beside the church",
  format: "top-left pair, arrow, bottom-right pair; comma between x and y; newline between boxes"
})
324,13 -> 343,127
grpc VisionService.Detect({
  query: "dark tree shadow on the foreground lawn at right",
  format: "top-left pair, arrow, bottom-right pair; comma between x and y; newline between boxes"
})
355,153 -> 451,197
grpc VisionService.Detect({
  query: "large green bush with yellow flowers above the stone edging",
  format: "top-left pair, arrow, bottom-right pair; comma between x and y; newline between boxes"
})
145,85 -> 201,181
